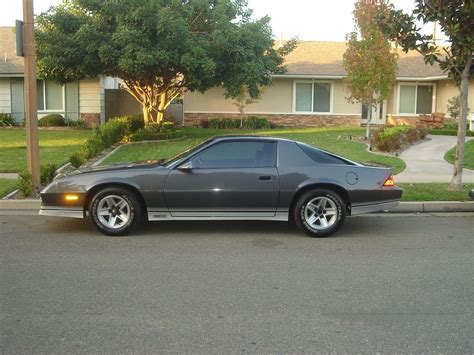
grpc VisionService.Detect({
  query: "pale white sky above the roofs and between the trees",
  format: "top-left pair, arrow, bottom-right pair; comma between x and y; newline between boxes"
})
0,0 -> 444,41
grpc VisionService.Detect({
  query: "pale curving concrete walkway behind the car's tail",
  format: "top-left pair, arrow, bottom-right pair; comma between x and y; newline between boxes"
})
395,135 -> 474,183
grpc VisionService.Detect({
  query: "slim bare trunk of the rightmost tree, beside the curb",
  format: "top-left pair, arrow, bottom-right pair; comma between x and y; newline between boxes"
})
450,54 -> 472,191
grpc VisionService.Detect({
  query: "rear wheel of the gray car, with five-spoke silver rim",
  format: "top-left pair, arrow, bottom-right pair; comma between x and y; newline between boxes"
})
293,189 -> 347,238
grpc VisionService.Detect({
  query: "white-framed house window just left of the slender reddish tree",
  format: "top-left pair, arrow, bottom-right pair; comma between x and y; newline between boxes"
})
294,82 -> 331,112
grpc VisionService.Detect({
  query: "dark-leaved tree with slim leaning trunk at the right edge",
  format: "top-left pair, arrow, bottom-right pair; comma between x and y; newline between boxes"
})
377,0 -> 474,191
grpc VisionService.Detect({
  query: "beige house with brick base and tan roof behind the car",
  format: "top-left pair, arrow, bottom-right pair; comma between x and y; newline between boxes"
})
184,41 -> 474,126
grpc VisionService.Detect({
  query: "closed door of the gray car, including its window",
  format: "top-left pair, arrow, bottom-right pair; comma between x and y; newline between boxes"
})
164,139 -> 279,218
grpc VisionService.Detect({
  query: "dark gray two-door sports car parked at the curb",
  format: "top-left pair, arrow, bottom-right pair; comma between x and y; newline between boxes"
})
40,136 -> 402,237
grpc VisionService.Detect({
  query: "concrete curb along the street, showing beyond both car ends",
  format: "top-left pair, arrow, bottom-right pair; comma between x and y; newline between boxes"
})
0,200 -> 474,213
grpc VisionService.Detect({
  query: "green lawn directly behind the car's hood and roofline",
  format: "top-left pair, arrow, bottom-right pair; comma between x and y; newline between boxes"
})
103,127 -> 405,174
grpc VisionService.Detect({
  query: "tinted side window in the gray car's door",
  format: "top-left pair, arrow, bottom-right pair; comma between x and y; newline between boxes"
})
191,141 -> 276,169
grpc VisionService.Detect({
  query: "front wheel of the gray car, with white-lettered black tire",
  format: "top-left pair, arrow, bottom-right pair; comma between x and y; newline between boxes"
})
89,187 -> 142,237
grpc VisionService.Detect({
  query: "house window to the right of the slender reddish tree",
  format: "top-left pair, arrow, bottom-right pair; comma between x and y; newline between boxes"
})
398,85 -> 433,114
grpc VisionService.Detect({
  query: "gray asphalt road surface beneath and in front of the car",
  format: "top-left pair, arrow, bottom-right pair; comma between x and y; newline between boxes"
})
0,214 -> 474,354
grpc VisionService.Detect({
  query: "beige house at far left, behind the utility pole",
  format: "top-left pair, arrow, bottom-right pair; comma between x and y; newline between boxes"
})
0,27 -> 118,125
